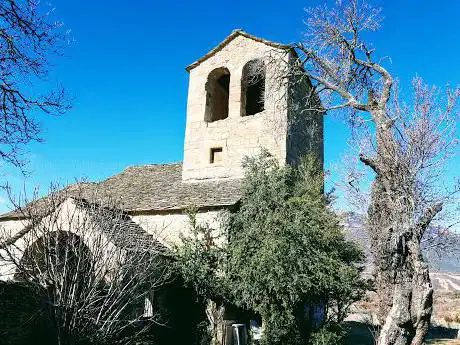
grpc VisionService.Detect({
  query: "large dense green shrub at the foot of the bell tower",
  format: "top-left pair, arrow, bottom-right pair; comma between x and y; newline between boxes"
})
176,153 -> 367,345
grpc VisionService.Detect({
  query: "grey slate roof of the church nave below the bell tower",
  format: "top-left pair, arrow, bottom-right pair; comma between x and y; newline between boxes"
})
0,163 -> 242,220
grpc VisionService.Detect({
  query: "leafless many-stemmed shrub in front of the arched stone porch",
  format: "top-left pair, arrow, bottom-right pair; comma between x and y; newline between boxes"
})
0,185 -> 169,344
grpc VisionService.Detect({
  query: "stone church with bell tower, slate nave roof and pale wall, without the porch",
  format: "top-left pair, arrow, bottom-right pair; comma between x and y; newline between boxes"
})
0,30 -> 323,279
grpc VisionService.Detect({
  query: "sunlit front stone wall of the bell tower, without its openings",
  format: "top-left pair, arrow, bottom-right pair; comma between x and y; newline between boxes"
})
182,36 -> 288,181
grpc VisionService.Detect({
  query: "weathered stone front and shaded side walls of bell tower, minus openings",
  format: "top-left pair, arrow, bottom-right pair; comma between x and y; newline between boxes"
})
182,30 -> 323,181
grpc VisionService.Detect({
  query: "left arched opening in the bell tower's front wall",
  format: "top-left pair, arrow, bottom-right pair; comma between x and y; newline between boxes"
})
204,67 -> 230,122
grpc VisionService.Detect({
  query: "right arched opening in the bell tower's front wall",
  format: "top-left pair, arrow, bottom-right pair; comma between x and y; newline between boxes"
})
241,60 -> 265,116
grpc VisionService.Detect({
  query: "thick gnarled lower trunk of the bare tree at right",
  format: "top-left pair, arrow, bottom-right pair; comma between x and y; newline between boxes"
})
369,177 -> 433,345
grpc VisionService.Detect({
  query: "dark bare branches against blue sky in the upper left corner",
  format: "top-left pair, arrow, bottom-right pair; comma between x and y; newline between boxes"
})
0,0 -> 69,167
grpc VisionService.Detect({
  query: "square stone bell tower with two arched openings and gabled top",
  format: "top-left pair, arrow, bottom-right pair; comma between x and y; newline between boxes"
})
182,30 -> 323,182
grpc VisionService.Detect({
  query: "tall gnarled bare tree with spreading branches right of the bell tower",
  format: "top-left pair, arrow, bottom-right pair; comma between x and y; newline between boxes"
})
289,0 -> 460,345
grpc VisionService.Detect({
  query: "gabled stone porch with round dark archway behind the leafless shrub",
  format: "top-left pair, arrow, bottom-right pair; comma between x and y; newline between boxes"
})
0,197 -> 174,318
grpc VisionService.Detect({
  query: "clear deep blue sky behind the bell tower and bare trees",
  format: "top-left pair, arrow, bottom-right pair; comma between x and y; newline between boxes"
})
0,0 -> 460,211
